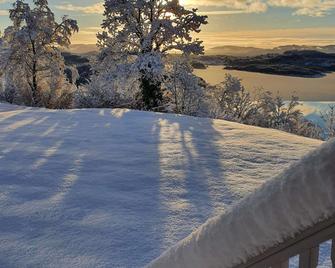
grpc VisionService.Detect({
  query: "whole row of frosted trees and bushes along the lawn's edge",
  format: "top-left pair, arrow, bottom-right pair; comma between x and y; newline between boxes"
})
0,0 -> 335,139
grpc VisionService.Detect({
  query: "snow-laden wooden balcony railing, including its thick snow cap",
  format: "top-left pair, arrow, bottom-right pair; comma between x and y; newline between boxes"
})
150,141 -> 335,268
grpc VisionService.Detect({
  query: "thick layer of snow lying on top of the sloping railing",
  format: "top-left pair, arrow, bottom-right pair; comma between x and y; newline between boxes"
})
149,140 -> 335,268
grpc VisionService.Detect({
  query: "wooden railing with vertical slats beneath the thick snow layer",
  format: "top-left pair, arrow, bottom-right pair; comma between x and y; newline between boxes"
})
235,216 -> 335,268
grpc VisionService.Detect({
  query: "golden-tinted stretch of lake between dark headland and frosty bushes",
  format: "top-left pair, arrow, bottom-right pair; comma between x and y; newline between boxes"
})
194,66 -> 335,102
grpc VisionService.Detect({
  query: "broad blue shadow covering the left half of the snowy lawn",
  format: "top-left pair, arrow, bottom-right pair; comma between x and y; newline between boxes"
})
0,110 -> 164,267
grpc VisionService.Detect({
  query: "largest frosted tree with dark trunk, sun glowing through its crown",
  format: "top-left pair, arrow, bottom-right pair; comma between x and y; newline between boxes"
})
98,0 -> 207,109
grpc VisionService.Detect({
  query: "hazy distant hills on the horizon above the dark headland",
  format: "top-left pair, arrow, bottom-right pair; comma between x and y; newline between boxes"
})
206,45 -> 335,57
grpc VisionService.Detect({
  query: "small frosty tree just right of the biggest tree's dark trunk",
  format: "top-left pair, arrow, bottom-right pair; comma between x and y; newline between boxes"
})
164,58 -> 204,115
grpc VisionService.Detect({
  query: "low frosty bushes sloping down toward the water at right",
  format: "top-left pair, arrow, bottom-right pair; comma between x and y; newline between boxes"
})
207,74 -> 322,139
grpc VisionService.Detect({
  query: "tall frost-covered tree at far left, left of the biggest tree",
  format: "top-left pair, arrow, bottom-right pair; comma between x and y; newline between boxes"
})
4,0 -> 79,106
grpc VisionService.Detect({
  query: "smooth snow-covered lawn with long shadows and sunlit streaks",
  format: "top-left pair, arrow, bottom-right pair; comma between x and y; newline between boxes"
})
0,104 -> 322,268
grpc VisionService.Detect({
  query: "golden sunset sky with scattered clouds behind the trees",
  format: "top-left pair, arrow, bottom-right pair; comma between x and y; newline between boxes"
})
0,0 -> 335,49
